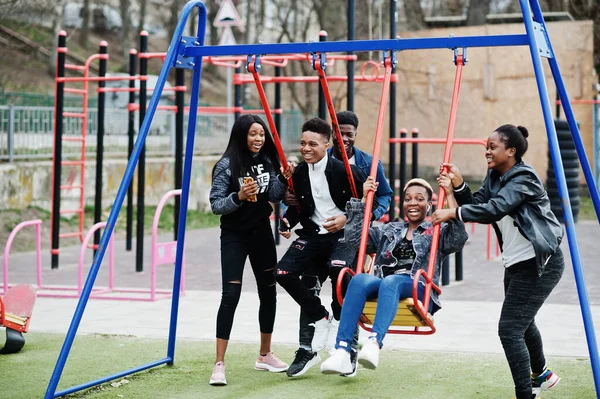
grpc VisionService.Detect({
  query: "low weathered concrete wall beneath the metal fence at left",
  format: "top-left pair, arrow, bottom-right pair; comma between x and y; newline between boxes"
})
0,156 -> 219,210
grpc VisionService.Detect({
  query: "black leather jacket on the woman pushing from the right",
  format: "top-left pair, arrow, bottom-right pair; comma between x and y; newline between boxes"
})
454,162 -> 563,276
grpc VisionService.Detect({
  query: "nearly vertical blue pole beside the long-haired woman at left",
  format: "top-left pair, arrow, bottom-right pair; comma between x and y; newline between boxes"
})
167,2 -> 206,364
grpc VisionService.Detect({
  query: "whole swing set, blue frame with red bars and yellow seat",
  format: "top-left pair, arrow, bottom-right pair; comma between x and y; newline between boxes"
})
45,0 -> 600,399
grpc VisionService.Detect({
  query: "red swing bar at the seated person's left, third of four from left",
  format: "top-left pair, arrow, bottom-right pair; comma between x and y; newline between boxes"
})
356,57 -> 393,273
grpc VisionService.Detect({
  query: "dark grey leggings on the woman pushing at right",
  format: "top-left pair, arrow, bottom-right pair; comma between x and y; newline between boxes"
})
498,248 -> 565,399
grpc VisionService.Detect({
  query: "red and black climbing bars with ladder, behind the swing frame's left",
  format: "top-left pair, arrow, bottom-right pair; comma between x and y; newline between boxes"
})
51,31 -> 390,272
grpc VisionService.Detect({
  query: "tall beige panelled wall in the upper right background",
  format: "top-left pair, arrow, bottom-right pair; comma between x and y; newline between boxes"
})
336,21 -> 597,181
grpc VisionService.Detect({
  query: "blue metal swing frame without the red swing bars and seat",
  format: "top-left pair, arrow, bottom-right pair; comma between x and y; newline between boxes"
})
45,0 -> 600,399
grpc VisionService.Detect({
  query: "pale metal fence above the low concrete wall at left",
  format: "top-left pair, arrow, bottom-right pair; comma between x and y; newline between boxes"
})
0,106 -> 303,162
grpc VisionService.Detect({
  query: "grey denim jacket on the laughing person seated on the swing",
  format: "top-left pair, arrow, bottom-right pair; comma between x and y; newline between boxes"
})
344,198 -> 469,313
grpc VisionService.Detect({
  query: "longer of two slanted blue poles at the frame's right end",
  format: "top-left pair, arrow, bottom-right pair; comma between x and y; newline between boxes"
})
519,0 -> 600,397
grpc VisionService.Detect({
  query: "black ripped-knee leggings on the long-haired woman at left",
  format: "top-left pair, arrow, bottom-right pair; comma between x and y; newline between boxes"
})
217,221 -> 277,340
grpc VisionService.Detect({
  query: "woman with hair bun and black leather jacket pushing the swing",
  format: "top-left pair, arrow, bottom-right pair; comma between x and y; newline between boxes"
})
432,125 -> 565,399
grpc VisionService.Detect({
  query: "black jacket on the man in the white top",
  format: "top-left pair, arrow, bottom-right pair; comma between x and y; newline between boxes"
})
283,157 -> 368,236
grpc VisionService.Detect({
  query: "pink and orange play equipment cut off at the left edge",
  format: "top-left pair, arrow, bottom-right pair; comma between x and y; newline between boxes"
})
0,284 -> 35,354
